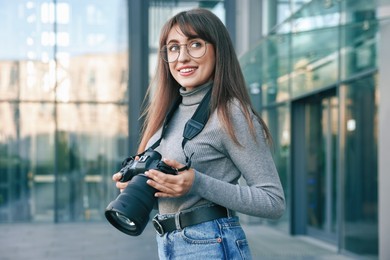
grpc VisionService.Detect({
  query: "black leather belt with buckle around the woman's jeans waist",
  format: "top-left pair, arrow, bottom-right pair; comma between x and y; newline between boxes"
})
152,205 -> 229,236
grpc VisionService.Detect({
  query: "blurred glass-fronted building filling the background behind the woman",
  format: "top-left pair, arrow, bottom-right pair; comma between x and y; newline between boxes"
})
0,0 -> 390,257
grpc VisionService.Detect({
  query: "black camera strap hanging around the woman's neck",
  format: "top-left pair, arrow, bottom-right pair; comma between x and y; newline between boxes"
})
145,88 -> 212,171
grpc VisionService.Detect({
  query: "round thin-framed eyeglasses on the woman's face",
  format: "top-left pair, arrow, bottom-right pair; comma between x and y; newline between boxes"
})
160,39 -> 208,62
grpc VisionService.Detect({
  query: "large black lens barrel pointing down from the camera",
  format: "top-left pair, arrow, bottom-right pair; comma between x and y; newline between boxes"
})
105,174 -> 156,236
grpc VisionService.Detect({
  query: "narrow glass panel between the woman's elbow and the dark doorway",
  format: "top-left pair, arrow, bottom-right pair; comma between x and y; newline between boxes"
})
263,104 -> 291,232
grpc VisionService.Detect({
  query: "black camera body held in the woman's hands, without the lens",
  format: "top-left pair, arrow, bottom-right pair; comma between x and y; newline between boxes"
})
119,148 -> 177,182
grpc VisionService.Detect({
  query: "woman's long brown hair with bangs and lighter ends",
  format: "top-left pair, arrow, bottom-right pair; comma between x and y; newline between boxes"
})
138,8 -> 270,152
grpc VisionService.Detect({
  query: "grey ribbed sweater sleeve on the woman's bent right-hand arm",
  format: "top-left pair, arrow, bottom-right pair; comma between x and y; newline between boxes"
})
191,103 -> 285,219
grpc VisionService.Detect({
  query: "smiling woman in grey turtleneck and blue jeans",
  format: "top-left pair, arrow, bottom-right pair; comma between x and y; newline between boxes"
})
113,9 -> 285,259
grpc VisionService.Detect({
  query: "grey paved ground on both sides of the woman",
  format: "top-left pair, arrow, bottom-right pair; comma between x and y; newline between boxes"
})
0,222 -> 370,260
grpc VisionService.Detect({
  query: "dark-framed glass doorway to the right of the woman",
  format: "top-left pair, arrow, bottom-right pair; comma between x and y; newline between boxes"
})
292,88 -> 339,243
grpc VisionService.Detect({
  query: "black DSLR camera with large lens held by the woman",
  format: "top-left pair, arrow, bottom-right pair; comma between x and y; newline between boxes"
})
105,148 -> 177,236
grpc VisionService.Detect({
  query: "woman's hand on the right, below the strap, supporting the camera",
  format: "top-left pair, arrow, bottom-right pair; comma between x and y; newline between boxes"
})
145,159 -> 195,198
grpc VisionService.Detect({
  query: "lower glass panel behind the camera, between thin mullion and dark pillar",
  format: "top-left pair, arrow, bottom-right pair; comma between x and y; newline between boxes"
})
57,104 -> 128,221
